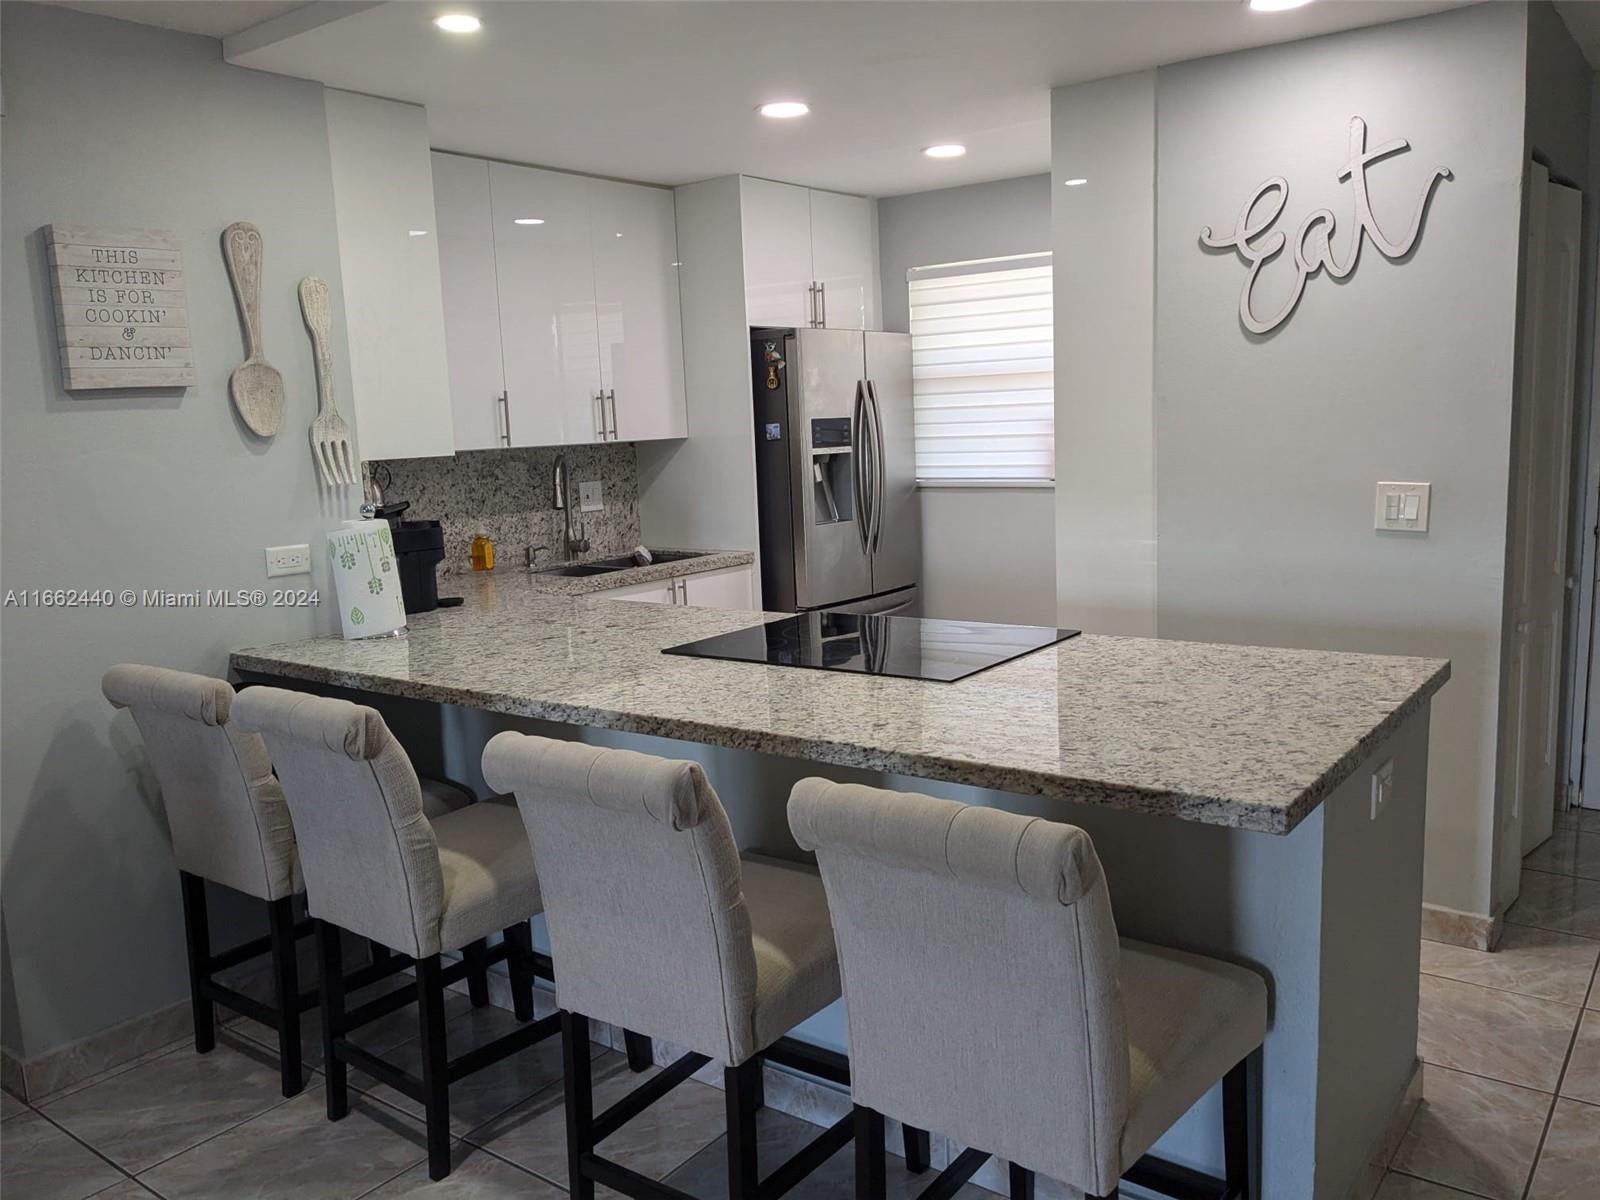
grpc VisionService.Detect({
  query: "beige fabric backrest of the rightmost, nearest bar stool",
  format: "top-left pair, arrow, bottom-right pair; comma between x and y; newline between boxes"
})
789,779 -> 1128,1195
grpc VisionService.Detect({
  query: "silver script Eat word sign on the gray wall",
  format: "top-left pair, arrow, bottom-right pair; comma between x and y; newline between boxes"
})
1200,117 -> 1453,333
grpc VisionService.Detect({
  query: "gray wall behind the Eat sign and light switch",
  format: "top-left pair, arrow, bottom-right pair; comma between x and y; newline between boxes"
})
1155,5 -> 1526,912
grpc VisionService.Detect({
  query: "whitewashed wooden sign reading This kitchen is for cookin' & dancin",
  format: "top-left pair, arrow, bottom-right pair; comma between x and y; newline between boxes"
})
45,224 -> 195,392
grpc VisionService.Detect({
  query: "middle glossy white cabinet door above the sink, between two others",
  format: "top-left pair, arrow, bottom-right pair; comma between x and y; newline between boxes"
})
490,163 -> 600,446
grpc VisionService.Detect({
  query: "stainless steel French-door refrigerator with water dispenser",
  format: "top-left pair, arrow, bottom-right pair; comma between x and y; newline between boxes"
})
750,330 -> 922,616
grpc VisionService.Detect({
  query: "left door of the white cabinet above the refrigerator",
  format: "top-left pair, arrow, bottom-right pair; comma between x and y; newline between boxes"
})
739,178 -> 816,328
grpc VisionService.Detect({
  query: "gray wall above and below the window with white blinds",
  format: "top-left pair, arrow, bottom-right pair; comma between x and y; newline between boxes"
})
878,174 -> 1056,624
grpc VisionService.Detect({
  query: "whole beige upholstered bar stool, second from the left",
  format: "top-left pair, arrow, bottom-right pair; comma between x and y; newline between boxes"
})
234,688 -> 560,1179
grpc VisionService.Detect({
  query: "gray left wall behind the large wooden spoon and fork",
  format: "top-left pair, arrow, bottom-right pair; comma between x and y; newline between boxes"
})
0,3 -> 354,1056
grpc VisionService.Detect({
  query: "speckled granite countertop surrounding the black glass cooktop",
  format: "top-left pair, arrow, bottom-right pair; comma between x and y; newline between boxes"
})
232,563 -> 1450,834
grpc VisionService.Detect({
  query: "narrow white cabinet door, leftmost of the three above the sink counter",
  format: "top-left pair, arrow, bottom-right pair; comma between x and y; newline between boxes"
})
432,154 -> 506,450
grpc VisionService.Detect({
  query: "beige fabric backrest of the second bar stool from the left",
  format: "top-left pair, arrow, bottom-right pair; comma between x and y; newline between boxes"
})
234,688 -> 445,958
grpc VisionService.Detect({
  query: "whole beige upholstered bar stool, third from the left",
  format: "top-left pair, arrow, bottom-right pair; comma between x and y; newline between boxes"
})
483,733 -> 902,1200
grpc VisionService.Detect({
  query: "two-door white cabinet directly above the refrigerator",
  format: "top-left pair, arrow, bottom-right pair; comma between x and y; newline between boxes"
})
739,176 -> 878,330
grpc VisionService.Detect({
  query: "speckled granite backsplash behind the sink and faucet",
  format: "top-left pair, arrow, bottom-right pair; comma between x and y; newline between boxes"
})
373,442 -> 640,574
